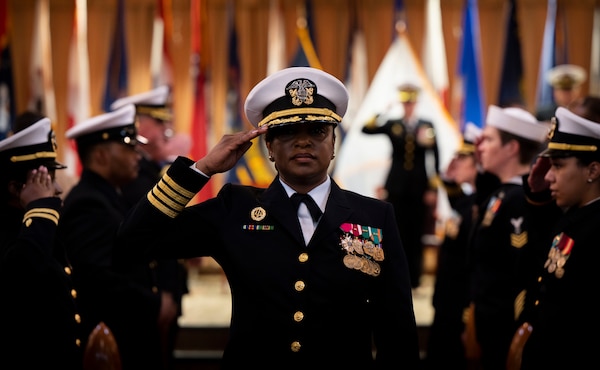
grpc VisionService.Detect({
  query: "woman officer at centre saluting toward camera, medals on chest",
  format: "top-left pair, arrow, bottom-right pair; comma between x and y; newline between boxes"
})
116,67 -> 420,369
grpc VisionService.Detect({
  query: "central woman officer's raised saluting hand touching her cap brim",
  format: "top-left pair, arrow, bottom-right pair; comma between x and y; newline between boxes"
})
195,126 -> 267,176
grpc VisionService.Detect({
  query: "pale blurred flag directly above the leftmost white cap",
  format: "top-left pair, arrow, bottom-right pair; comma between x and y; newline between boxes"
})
27,0 -> 57,122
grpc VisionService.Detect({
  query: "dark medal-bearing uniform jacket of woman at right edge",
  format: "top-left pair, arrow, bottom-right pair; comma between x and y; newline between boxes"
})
521,193 -> 600,370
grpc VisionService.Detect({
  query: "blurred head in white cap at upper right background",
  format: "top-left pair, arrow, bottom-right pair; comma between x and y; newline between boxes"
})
536,64 -> 587,121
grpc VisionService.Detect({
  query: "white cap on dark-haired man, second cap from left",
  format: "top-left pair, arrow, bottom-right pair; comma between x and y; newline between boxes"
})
66,104 -> 147,147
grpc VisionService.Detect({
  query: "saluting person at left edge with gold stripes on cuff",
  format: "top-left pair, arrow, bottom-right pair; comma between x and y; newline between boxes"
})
0,112 -> 89,369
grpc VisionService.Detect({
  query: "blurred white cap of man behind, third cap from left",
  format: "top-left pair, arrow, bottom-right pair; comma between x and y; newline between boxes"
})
110,85 -> 173,121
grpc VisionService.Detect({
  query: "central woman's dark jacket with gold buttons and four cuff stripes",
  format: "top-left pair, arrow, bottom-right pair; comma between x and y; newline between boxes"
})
115,157 -> 419,369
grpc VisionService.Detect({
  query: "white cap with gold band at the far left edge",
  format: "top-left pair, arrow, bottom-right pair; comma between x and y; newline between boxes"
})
0,117 -> 66,170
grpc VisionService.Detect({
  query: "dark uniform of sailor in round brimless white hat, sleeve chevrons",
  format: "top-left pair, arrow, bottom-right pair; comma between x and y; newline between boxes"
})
469,177 -> 534,369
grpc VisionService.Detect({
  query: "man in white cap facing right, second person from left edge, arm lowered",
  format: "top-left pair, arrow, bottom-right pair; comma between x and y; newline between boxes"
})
58,104 -> 177,370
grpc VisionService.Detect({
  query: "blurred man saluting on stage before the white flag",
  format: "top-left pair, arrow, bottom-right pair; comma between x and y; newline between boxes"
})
362,83 -> 439,288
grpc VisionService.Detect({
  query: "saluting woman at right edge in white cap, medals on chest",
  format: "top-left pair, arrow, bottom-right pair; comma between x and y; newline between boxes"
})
520,96 -> 600,369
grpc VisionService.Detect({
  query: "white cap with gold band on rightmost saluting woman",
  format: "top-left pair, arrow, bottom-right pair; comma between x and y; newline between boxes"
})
540,107 -> 600,157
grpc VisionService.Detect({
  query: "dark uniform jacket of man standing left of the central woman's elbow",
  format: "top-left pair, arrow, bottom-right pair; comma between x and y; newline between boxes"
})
59,169 -> 162,370
